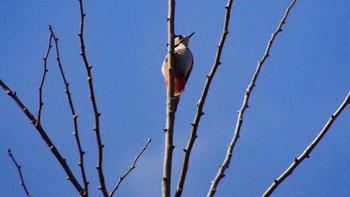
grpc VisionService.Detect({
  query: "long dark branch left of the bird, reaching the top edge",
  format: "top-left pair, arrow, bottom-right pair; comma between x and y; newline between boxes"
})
78,0 -> 108,197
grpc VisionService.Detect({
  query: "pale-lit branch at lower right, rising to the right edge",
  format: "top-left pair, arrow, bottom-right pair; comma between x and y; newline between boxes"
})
262,92 -> 350,197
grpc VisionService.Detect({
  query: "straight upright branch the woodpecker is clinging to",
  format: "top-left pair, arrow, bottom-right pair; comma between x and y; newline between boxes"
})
162,0 -> 175,197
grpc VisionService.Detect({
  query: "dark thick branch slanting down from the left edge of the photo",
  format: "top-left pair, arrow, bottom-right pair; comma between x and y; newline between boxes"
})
0,79 -> 84,193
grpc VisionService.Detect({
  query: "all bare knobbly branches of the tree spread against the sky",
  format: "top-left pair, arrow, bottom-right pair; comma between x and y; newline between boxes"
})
0,0 -> 350,197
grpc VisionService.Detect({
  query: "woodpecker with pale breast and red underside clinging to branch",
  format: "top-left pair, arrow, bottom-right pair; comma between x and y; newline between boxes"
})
162,32 -> 194,111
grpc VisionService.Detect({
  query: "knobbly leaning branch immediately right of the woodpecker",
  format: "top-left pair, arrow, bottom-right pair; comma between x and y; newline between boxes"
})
175,0 -> 233,197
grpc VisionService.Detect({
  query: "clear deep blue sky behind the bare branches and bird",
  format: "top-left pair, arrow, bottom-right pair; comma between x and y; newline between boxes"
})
0,0 -> 350,197
